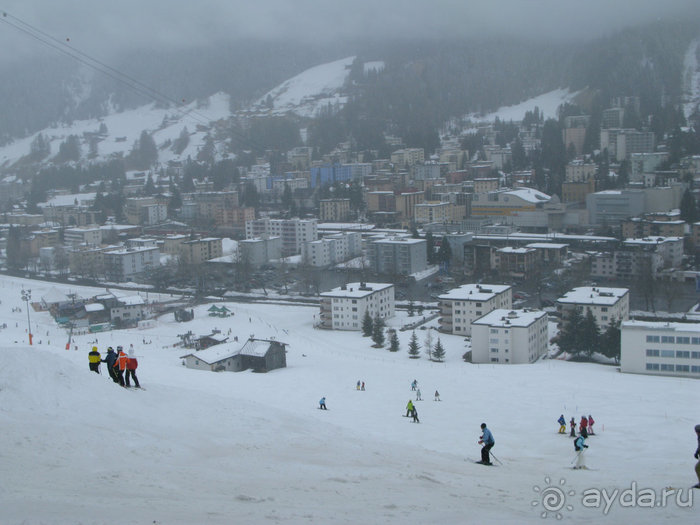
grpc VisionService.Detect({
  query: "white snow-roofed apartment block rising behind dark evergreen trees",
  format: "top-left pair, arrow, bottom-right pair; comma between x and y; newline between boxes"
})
557,286 -> 630,330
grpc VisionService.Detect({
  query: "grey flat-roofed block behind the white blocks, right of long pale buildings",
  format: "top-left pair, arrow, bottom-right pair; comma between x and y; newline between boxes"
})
367,237 -> 428,275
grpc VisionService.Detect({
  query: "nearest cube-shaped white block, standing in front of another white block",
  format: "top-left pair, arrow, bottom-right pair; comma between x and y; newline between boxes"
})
472,309 -> 549,364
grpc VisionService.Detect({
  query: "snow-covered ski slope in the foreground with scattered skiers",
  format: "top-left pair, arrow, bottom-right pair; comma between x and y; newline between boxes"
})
0,277 -> 700,525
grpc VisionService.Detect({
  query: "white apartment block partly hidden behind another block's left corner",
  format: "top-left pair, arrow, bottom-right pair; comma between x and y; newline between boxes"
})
438,284 -> 513,335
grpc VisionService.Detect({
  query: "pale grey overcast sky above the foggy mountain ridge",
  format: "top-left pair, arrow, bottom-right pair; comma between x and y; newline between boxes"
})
0,0 -> 700,60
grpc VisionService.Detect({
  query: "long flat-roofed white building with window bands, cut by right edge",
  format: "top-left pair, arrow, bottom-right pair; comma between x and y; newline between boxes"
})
620,321 -> 700,378
